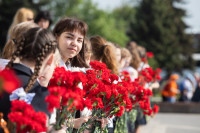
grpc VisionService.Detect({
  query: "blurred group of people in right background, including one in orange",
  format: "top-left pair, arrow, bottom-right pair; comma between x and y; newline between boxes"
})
161,72 -> 200,103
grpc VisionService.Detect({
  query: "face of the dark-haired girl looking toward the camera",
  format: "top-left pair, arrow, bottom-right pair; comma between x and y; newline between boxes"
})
57,31 -> 84,62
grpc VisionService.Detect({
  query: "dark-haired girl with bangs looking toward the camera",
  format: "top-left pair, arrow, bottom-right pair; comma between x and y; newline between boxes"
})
53,18 -> 108,129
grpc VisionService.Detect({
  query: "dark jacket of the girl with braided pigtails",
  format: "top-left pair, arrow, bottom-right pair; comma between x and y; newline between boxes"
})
0,63 -> 50,120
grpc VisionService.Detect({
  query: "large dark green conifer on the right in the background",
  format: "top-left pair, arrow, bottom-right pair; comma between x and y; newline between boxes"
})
128,0 -> 194,73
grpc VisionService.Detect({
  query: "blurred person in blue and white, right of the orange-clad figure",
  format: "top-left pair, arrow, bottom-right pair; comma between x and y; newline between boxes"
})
179,73 -> 196,102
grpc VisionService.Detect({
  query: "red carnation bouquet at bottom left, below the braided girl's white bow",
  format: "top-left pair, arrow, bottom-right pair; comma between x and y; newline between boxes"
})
8,100 -> 47,133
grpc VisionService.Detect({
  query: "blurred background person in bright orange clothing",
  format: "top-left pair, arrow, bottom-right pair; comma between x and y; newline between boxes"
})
162,74 -> 179,103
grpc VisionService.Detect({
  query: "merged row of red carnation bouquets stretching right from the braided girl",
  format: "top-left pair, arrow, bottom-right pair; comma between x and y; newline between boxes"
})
46,61 -> 159,133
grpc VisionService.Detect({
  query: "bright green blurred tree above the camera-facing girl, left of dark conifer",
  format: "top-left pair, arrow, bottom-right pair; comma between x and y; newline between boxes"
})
52,0 -> 129,46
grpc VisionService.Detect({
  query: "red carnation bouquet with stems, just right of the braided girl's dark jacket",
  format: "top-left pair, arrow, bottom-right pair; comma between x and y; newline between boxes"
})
46,67 -> 90,132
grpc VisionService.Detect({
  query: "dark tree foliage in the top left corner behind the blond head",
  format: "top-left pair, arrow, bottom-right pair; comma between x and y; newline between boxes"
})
0,0 -> 49,51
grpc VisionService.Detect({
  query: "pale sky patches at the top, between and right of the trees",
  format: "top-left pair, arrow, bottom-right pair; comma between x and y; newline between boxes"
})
93,0 -> 200,33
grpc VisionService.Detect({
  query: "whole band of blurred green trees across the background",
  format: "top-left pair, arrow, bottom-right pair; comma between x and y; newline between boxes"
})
0,0 -> 194,72
